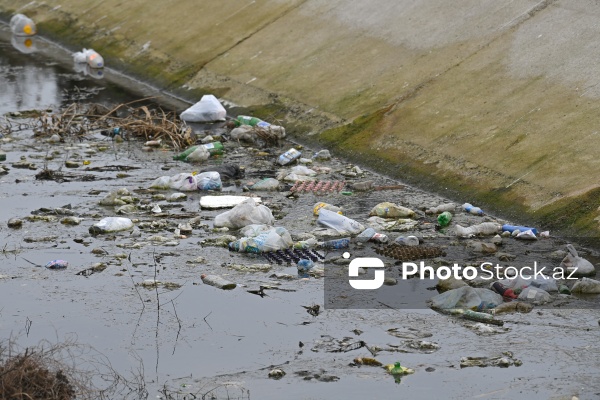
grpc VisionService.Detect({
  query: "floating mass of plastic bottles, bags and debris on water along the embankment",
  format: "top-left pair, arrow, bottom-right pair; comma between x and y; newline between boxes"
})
2,91 -> 600,388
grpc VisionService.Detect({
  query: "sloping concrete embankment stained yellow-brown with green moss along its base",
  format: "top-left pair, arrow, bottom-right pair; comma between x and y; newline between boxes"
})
0,0 -> 600,241
